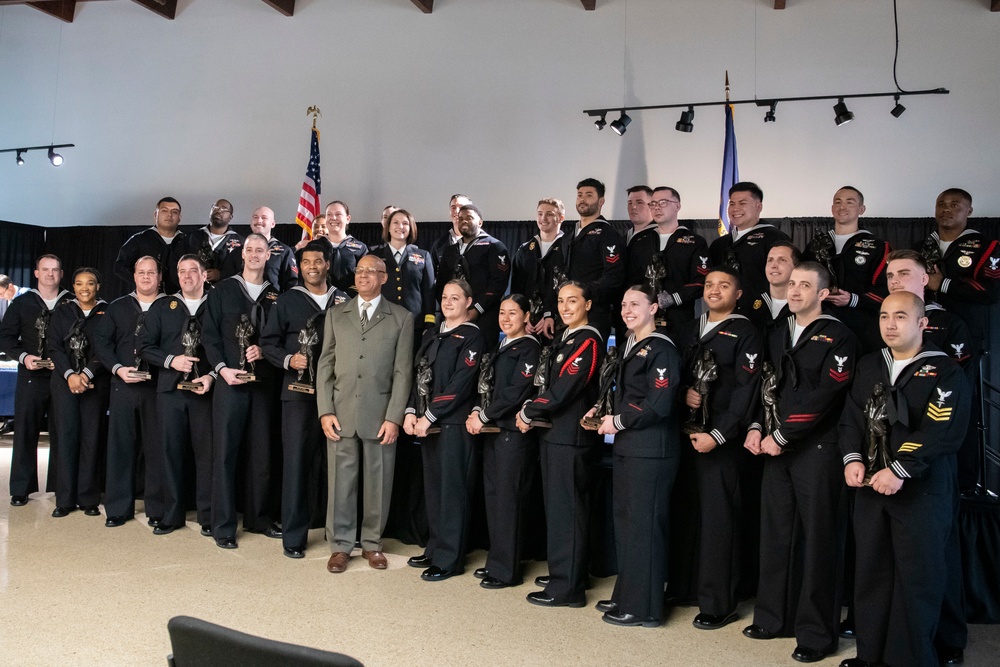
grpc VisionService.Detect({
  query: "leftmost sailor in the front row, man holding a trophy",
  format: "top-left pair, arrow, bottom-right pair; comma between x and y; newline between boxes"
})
0,255 -> 72,507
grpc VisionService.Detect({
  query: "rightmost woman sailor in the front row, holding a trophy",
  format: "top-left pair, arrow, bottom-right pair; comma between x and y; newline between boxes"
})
587,285 -> 681,627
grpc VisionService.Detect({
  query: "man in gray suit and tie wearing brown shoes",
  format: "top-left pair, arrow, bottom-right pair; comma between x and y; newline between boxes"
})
316,255 -> 413,572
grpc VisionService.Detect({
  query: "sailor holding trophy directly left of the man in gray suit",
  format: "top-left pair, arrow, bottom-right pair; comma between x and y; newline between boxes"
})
260,242 -> 348,558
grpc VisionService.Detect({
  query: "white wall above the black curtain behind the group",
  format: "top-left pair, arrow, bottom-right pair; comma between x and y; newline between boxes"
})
0,0 -> 1000,226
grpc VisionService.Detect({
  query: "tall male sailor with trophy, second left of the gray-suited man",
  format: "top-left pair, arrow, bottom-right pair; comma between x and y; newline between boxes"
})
202,232 -> 281,549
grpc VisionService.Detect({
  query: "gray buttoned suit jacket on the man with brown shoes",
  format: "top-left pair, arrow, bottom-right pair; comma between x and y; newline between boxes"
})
316,297 -> 413,438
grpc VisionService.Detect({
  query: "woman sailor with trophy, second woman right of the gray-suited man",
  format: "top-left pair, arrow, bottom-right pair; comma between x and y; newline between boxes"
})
465,294 -> 542,589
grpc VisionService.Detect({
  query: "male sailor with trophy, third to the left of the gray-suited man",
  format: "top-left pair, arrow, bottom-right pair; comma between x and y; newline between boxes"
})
139,254 -> 216,536
